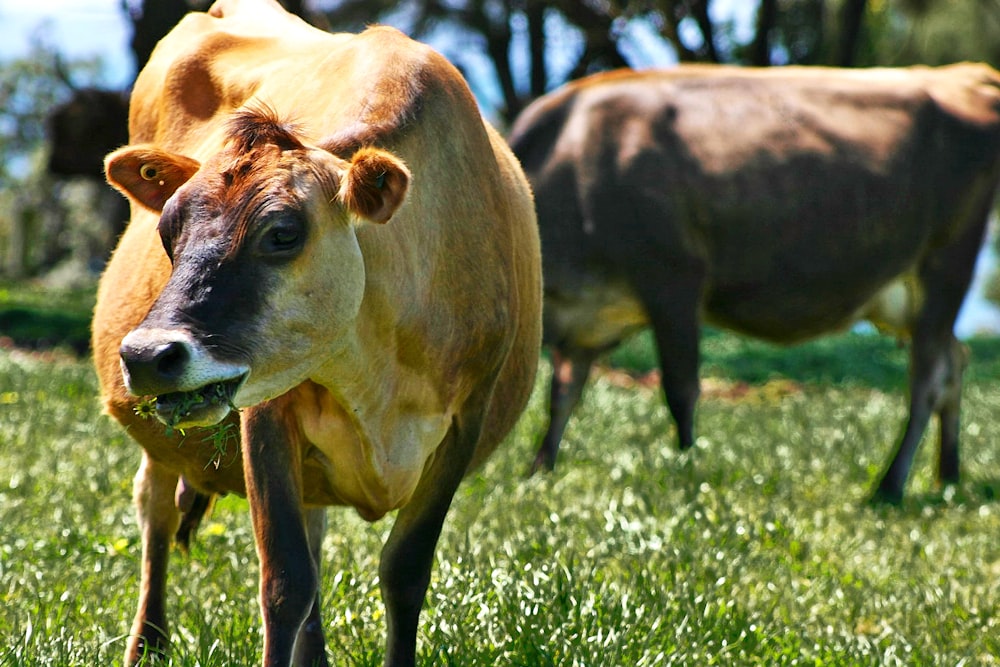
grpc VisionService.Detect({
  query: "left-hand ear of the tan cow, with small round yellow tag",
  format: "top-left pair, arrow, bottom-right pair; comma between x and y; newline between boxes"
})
104,146 -> 201,213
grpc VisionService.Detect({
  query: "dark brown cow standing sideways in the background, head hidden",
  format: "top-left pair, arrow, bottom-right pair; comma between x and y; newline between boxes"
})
510,65 -> 1000,502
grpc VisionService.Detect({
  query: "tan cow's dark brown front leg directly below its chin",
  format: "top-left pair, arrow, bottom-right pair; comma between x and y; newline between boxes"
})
241,403 -> 325,667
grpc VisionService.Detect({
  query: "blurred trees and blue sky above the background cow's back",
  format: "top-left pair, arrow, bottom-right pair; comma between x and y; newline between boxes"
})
306,0 -> 1000,121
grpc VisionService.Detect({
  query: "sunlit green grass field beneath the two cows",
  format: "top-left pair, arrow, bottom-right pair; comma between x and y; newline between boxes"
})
0,326 -> 1000,667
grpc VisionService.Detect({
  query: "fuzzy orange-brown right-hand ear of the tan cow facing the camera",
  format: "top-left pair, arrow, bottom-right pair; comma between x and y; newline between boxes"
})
339,148 -> 410,223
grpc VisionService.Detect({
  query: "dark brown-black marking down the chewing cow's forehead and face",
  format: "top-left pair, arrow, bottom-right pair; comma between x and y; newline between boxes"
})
137,106 -> 322,363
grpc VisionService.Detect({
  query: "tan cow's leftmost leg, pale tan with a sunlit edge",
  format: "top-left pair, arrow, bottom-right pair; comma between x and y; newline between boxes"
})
125,452 -> 180,665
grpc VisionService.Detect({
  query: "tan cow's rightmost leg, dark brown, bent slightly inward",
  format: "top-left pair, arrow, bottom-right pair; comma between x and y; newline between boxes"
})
379,392 -> 486,667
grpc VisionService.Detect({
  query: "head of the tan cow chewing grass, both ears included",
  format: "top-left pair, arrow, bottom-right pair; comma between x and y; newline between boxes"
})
105,104 -> 410,428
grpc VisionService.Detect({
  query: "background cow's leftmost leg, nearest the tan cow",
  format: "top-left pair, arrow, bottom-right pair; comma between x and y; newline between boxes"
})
530,347 -> 596,475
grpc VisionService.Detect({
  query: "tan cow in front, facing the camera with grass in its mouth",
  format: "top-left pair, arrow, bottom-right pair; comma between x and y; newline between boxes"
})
93,0 -> 541,666
